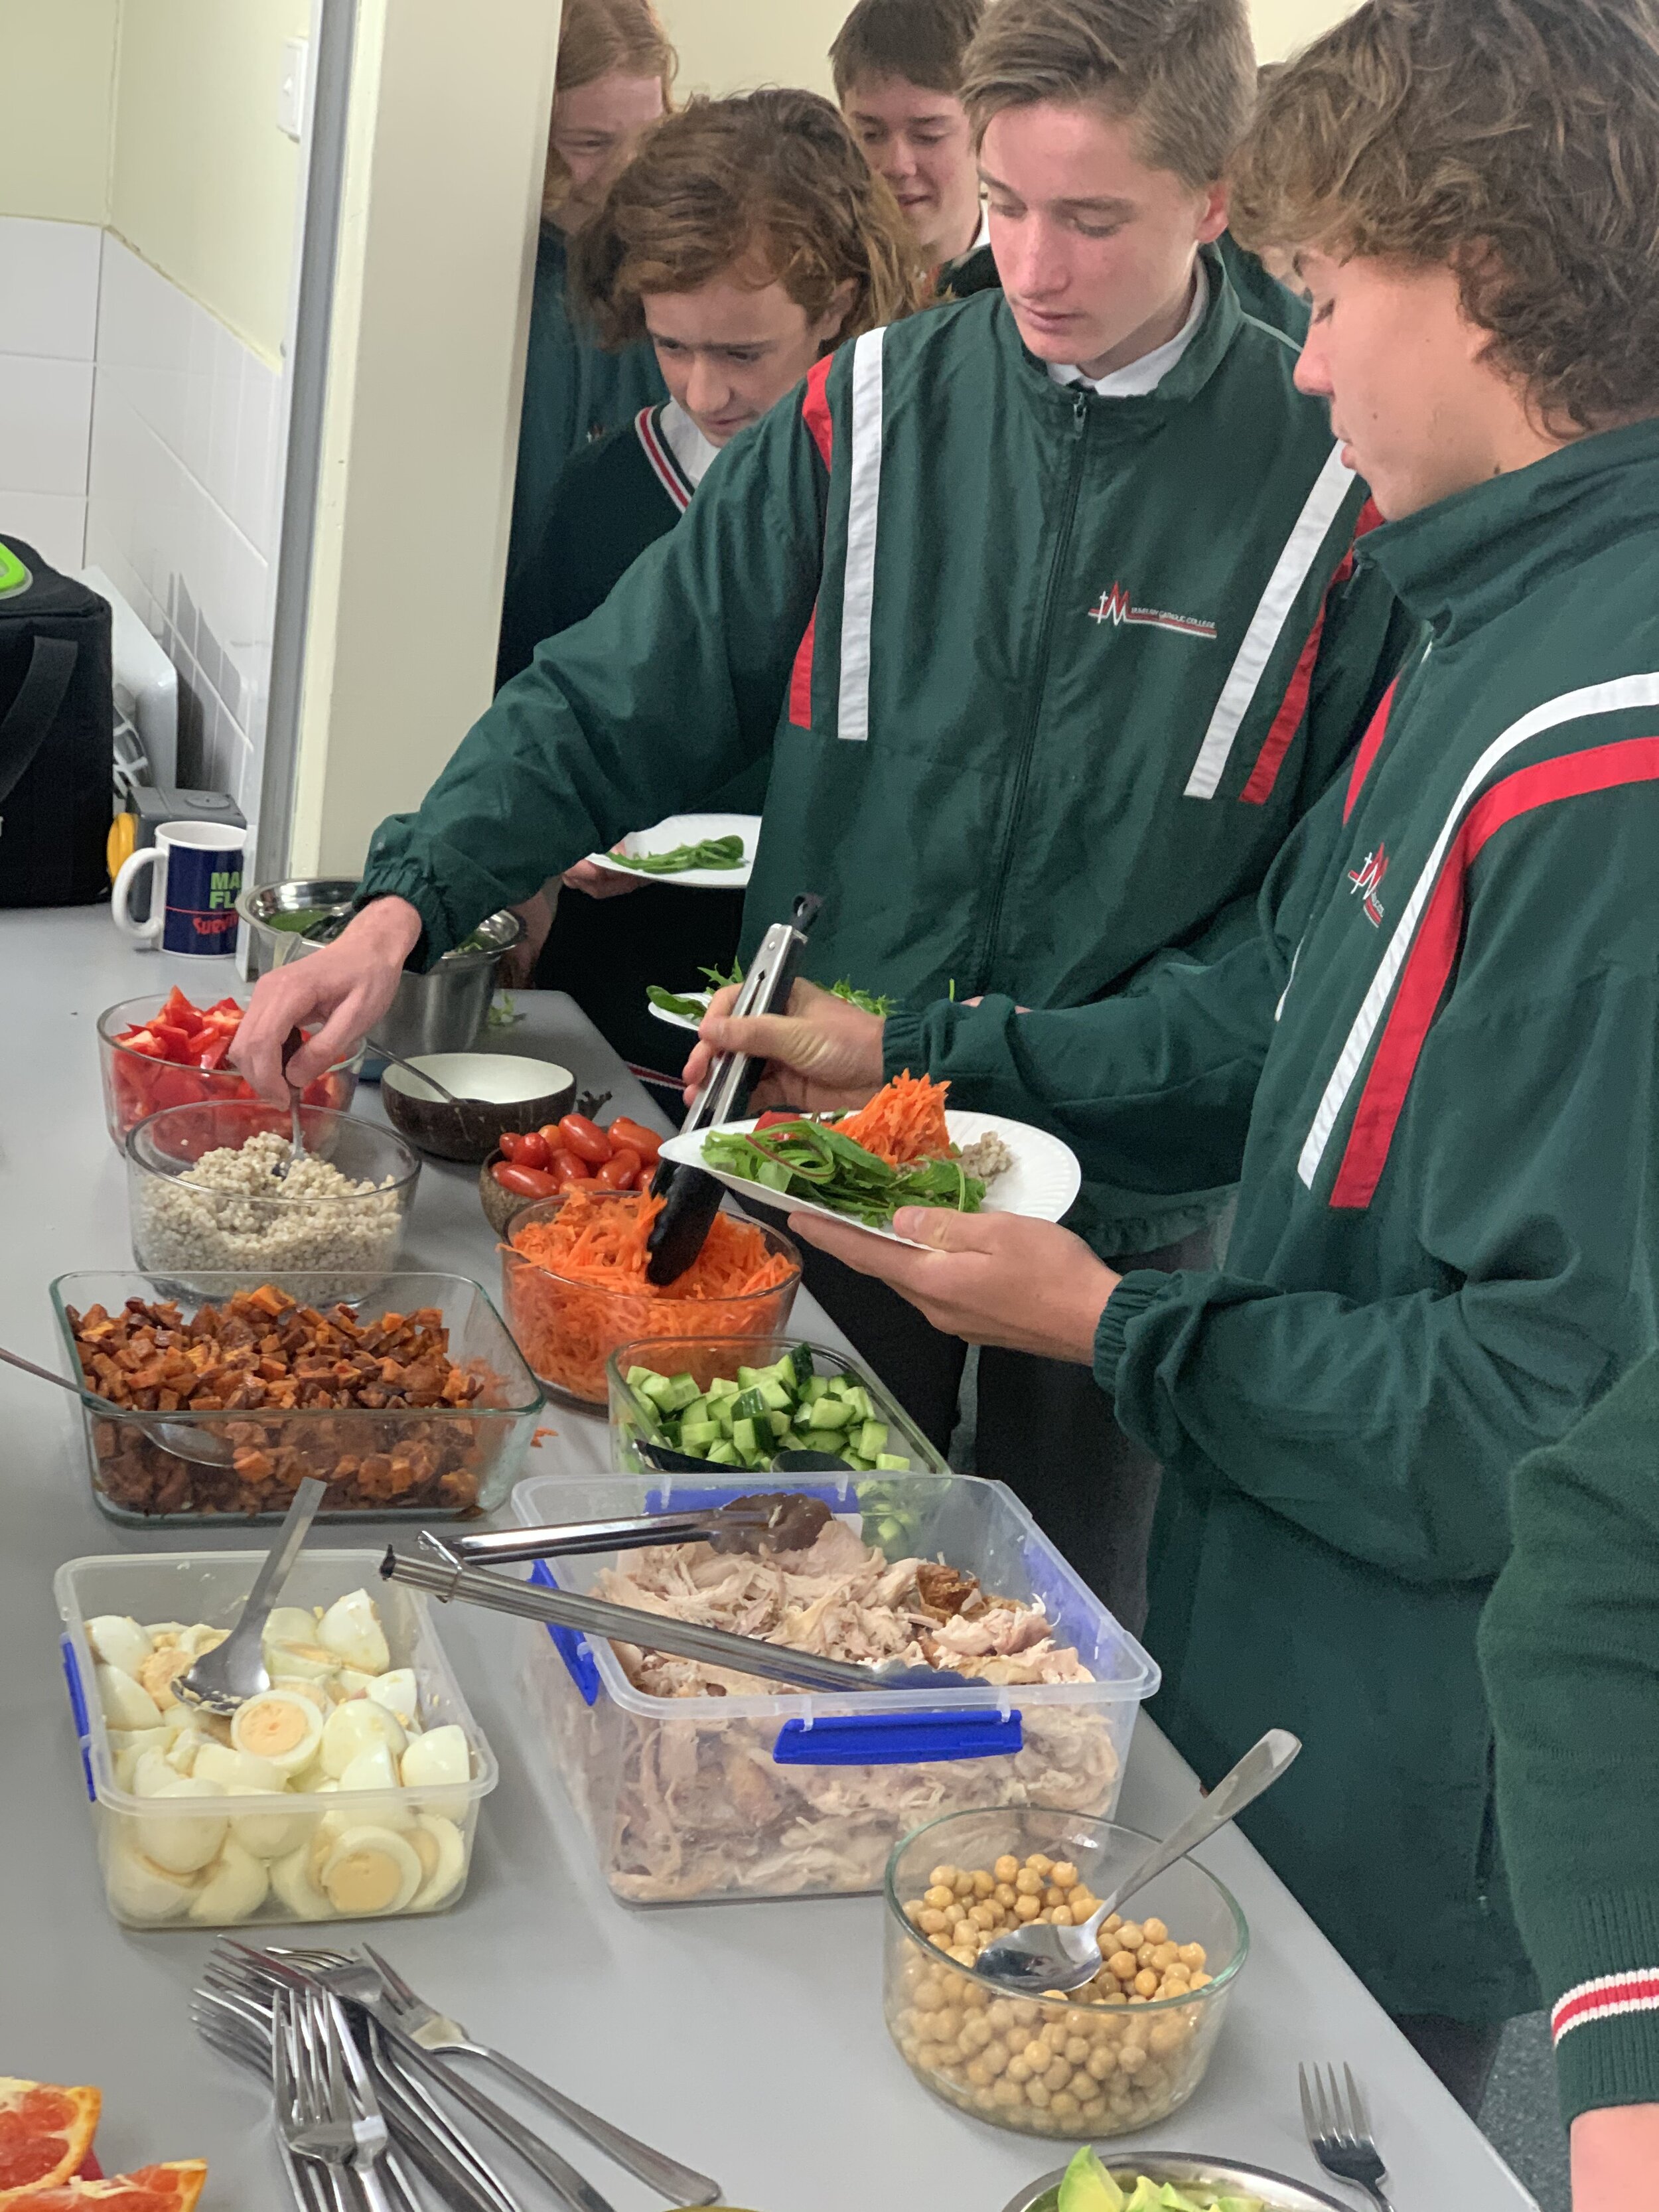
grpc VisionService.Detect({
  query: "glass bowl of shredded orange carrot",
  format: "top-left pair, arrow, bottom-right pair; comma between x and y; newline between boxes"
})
500,1185 -> 801,1407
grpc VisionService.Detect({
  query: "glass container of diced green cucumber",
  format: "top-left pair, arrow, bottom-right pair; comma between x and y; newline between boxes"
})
606,1336 -> 947,1475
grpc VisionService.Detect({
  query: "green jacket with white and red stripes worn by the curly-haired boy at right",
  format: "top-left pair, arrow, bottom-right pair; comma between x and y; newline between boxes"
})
887,423 -> 1659,2020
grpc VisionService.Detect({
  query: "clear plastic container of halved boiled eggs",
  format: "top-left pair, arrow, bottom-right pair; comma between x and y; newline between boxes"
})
53,1550 -> 498,1929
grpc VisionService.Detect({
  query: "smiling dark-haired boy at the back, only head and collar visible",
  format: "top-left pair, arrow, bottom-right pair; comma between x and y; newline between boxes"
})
830,0 -> 997,299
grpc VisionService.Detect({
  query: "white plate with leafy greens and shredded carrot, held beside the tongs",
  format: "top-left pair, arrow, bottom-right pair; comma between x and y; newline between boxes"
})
662,1073 -> 1082,1243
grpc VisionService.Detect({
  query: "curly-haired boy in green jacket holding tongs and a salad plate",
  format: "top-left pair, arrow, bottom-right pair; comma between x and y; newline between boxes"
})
677,0 -> 1659,2108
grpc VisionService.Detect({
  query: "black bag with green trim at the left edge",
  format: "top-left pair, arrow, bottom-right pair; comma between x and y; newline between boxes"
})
0,536 -> 115,907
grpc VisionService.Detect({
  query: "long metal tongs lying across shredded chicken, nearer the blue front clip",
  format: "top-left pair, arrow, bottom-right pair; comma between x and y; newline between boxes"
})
380,1550 -> 982,1701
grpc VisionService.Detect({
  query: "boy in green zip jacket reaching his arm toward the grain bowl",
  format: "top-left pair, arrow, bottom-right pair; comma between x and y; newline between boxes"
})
239,0 -> 1415,1615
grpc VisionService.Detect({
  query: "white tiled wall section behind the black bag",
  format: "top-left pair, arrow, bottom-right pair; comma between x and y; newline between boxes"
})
0,217 -> 283,821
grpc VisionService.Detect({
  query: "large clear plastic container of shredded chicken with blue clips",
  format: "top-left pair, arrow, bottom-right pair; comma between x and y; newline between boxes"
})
513,1471 -> 1159,1905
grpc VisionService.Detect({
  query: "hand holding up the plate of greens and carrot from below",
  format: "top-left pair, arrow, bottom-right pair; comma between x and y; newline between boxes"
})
790,1205 -> 1121,1367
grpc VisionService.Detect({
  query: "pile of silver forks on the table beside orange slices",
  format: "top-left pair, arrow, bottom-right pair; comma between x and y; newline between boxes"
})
190,1938 -> 721,2212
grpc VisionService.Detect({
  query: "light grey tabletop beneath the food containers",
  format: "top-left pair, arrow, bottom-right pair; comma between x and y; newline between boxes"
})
0,909 -> 1533,2212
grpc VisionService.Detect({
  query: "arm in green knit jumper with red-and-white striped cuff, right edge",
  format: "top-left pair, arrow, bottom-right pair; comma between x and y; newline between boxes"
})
1480,1353 -> 1659,2212
